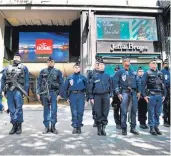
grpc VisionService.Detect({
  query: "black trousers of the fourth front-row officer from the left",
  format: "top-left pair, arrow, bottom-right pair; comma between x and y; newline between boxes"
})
94,93 -> 110,126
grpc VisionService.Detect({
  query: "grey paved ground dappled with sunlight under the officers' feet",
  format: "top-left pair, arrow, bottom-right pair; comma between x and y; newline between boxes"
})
0,105 -> 170,155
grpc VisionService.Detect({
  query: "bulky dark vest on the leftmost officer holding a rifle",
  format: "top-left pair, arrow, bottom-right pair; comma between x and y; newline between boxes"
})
6,64 -> 25,88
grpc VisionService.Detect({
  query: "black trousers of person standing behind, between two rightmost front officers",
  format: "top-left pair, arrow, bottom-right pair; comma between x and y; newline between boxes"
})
138,98 -> 147,124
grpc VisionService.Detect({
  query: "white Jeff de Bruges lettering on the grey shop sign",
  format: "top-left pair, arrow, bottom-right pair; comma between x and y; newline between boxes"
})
110,43 -> 148,52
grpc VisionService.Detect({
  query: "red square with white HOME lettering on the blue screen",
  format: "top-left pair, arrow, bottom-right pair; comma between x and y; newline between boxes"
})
36,39 -> 53,54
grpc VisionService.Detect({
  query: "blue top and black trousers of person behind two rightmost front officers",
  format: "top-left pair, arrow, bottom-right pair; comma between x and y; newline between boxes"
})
136,76 -> 148,125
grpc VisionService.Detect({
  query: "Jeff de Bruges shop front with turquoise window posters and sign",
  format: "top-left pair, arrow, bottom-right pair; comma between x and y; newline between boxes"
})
95,15 -> 161,75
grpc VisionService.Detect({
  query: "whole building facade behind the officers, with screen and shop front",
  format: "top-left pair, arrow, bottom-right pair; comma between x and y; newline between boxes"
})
0,0 -> 166,102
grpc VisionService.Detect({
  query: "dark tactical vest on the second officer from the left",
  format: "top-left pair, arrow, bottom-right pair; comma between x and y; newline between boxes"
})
41,68 -> 59,91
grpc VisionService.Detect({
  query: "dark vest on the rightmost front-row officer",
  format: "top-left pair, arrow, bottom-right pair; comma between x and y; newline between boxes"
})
147,70 -> 164,91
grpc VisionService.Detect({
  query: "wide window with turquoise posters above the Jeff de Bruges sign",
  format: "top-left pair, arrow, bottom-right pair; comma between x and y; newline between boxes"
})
96,16 -> 158,41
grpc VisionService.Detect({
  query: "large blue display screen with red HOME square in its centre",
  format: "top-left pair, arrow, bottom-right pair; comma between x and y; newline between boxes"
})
19,32 -> 69,62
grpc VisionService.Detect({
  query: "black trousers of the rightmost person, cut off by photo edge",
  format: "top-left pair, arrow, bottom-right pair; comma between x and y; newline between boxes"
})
163,89 -> 170,125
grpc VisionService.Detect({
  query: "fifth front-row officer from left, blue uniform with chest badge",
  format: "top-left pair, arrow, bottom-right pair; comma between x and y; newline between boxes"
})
114,57 -> 140,135
